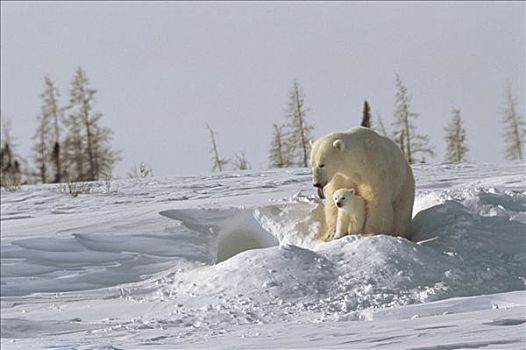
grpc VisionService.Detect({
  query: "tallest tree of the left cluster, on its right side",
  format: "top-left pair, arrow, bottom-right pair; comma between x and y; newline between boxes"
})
66,67 -> 119,181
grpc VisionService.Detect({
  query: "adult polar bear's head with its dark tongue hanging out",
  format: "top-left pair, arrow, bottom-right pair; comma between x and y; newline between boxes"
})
310,135 -> 345,198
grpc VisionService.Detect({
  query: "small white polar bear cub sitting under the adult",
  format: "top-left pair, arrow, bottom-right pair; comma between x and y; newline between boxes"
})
332,188 -> 365,239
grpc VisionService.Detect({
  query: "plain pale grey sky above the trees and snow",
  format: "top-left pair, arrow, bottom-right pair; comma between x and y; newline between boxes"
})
1,1 -> 526,176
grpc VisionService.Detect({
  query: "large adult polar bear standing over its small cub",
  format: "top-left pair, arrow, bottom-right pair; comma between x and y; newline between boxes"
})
311,127 -> 415,240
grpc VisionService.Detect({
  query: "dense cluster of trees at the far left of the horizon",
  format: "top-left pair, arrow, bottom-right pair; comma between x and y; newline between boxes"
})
0,67 -> 119,187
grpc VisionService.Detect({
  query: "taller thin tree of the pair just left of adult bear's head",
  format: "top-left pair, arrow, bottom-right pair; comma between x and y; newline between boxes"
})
287,80 -> 314,167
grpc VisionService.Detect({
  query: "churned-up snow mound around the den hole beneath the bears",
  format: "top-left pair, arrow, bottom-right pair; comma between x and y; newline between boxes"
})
144,186 -> 526,322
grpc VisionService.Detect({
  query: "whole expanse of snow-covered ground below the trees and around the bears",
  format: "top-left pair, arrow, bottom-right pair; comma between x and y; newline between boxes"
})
1,163 -> 526,349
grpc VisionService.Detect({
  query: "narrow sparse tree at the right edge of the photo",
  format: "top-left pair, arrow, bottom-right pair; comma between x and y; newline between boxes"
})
500,82 -> 526,160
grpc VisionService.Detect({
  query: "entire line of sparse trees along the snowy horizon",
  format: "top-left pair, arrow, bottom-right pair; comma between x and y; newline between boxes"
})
0,71 -> 526,189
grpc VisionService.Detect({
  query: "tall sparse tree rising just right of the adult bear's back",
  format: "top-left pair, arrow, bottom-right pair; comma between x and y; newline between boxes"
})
393,74 -> 435,164
